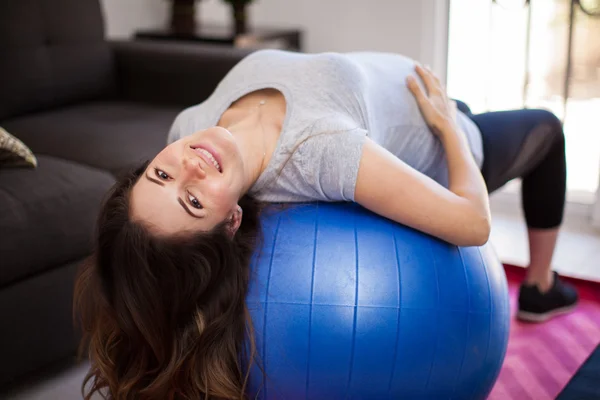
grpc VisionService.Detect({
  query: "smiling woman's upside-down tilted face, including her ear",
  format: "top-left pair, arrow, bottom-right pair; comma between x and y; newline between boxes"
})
131,127 -> 244,235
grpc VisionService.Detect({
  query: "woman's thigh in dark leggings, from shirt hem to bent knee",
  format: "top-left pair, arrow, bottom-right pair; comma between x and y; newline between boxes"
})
470,110 -> 562,192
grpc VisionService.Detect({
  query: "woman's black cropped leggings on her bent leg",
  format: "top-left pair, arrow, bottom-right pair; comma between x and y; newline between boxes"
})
457,102 -> 567,229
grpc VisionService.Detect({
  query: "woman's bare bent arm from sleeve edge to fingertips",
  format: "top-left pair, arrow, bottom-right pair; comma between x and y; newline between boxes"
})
354,67 -> 490,246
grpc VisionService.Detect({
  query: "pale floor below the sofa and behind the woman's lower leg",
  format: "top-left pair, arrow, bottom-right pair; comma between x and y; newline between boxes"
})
0,203 -> 600,400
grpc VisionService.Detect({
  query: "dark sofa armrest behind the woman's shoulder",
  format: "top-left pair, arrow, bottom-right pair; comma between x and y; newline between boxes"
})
110,40 -> 251,107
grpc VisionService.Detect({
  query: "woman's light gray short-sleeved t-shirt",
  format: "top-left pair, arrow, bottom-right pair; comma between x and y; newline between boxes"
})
168,50 -> 483,202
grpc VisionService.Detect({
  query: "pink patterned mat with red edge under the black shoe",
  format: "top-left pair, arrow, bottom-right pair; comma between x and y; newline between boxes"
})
489,266 -> 600,400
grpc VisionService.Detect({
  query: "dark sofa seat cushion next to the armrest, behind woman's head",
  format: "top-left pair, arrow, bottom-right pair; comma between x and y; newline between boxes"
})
2,102 -> 179,173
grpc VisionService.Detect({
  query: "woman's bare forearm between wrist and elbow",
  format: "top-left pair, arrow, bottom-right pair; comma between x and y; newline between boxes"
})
439,124 -> 490,219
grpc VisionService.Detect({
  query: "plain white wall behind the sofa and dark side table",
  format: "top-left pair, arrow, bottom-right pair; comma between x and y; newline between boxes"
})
102,0 -> 448,76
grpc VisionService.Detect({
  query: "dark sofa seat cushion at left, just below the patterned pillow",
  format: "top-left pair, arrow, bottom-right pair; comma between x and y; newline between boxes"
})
0,156 -> 114,287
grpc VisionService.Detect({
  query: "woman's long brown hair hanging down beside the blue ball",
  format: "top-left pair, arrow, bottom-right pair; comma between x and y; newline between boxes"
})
73,164 -> 260,400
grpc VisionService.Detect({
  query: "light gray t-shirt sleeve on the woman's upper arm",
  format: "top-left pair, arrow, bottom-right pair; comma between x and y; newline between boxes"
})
299,129 -> 367,201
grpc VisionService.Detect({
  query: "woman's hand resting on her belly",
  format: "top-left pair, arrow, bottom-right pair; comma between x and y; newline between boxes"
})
406,64 -> 456,137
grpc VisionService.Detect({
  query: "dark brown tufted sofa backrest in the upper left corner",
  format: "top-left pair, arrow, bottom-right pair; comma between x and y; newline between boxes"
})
0,0 -> 114,120
